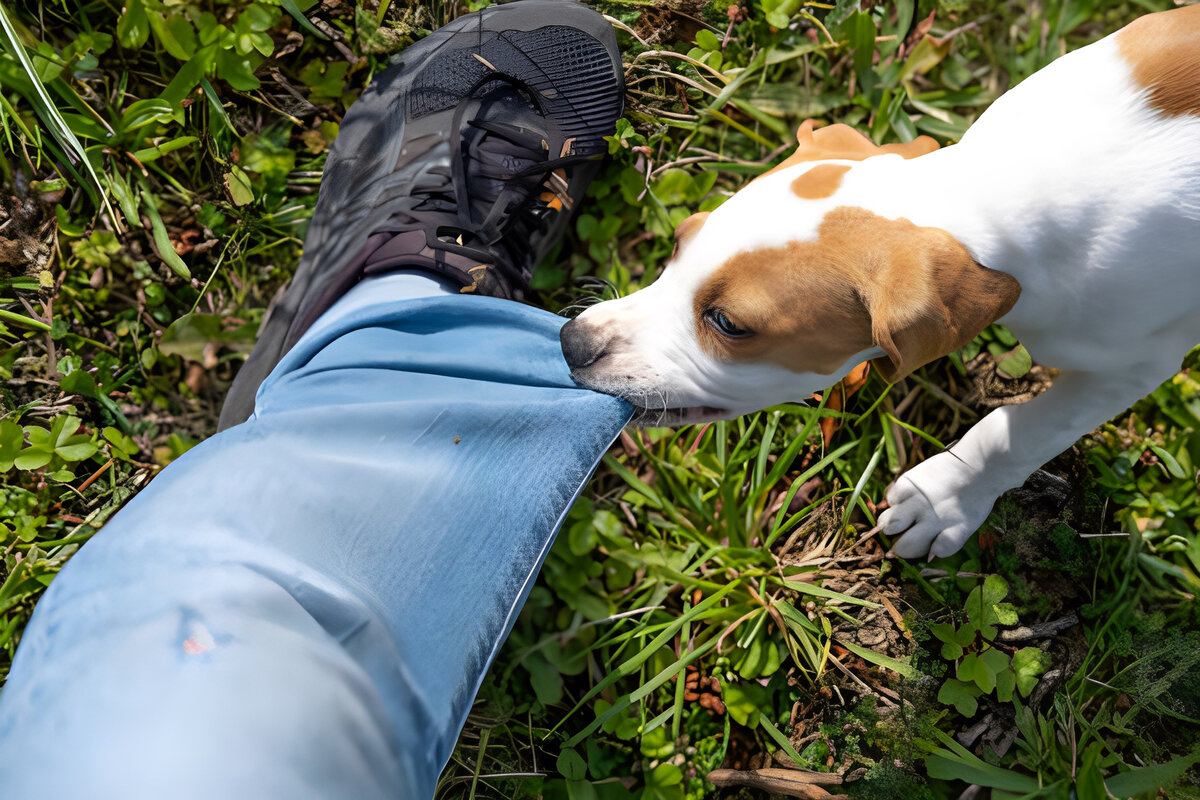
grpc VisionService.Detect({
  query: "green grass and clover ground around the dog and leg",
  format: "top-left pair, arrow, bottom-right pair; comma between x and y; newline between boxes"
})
0,0 -> 1200,800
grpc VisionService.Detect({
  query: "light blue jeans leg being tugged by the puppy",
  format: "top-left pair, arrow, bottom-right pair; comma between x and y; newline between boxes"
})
0,273 -> 630,800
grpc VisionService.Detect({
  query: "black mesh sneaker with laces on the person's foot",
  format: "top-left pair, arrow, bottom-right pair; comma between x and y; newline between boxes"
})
218,0 -> 624,429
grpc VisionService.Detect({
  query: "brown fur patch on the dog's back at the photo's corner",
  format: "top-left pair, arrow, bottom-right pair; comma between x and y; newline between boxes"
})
1117,6 -> 1200,116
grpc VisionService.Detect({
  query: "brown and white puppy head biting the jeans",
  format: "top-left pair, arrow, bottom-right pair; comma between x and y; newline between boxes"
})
562,122 -> 1020,425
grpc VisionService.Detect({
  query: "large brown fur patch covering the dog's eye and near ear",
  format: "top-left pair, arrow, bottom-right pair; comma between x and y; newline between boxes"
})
694,206 -> 1021,383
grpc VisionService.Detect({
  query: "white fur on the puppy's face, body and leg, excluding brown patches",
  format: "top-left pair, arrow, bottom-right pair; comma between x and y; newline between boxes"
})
568,29 -> 1200,557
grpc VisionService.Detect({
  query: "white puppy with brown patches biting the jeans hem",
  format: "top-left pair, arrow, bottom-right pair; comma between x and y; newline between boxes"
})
560,6 -> 1200,558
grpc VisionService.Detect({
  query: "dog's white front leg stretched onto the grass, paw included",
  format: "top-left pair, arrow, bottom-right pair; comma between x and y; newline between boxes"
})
880,363 -> 1177,558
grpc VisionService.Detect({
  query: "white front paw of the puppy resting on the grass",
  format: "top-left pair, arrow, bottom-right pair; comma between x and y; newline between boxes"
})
878,452 -> 998,559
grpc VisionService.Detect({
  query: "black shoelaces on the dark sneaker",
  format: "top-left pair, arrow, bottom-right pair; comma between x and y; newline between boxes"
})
384,72 -> 595,284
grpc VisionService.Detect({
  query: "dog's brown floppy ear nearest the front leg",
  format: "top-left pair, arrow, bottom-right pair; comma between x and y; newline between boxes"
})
862,219 -> 1021,383
